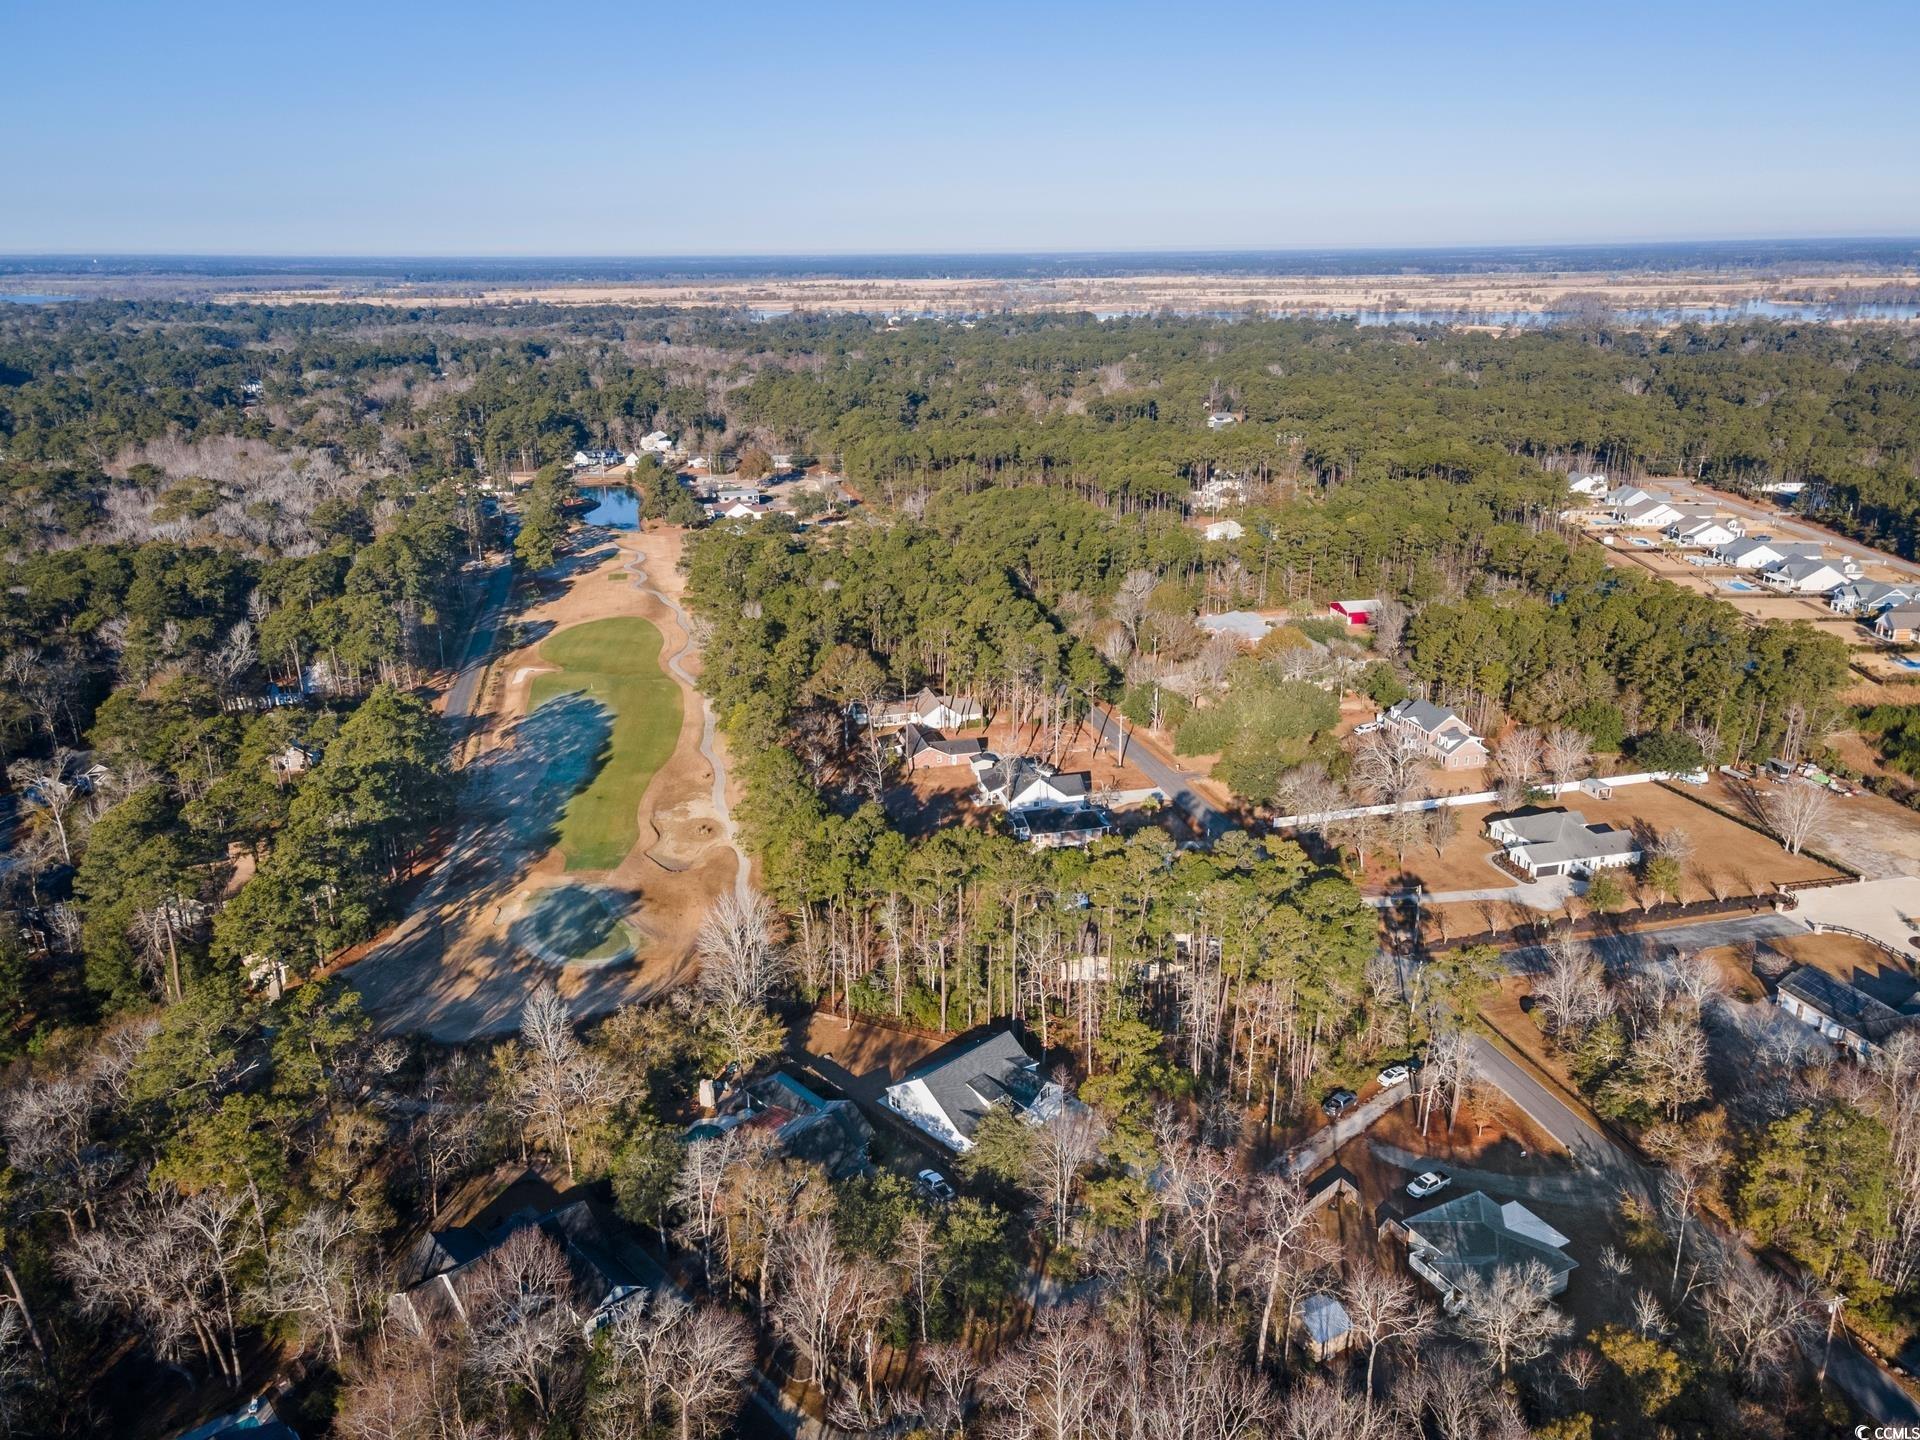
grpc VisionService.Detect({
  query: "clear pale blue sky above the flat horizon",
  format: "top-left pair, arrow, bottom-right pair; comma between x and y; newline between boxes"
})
0,0 -> 1920,255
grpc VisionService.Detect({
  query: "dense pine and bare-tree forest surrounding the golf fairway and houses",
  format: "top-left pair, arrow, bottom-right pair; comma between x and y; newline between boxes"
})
0,301 -> 1920,1440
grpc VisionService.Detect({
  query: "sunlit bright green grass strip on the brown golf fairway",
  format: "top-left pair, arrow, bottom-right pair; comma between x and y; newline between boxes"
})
532,616 -> 680,870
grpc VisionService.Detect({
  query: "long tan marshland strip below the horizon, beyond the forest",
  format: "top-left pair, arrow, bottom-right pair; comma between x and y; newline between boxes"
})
172,271 -> 1912,313
